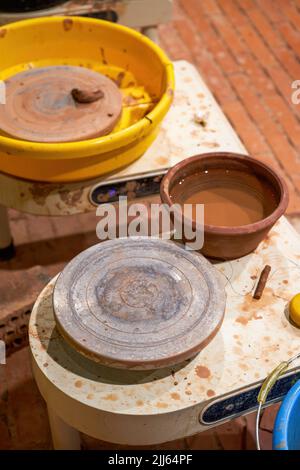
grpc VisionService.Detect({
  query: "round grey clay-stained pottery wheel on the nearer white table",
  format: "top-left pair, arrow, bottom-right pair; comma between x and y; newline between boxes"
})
53,237 -> 225,369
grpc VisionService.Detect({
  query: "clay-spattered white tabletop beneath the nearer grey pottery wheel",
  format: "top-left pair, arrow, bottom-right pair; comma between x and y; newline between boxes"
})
30,217 -> 300,422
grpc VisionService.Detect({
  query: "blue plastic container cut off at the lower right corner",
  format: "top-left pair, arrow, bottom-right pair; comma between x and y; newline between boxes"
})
273,380 -> 300,450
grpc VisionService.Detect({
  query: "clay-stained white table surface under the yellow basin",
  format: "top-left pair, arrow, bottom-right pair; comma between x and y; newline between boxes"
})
0,61 -> 246,215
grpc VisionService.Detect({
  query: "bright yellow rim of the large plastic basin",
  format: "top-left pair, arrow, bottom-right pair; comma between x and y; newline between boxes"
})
0,16 -> 175,159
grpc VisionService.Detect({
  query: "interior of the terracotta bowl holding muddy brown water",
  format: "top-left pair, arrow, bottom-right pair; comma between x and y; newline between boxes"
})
170,168 -> 278,227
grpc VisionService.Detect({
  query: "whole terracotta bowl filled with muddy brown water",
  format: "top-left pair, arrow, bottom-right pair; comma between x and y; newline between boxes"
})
160,152 -> 288,260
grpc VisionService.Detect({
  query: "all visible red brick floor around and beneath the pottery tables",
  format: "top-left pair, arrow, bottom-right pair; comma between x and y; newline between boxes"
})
0,0 -> 300,449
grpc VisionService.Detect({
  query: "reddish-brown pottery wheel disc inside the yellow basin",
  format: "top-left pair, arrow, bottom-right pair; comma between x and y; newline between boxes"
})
0,66 -> 122,142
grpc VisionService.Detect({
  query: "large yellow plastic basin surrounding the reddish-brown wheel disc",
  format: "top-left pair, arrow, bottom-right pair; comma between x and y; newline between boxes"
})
0,17 -> 174,182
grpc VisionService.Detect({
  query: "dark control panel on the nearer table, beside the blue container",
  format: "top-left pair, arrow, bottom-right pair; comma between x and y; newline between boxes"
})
200,372 -> 300,424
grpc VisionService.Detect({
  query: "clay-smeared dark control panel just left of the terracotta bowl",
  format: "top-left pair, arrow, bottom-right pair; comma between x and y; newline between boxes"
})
90,174 -> 164,205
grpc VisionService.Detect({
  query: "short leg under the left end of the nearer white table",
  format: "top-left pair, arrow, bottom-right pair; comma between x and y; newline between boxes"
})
48,407 -> 80,450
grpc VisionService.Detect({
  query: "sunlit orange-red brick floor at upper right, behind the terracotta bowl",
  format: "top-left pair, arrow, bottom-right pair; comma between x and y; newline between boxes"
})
160,0 -> 300,216
